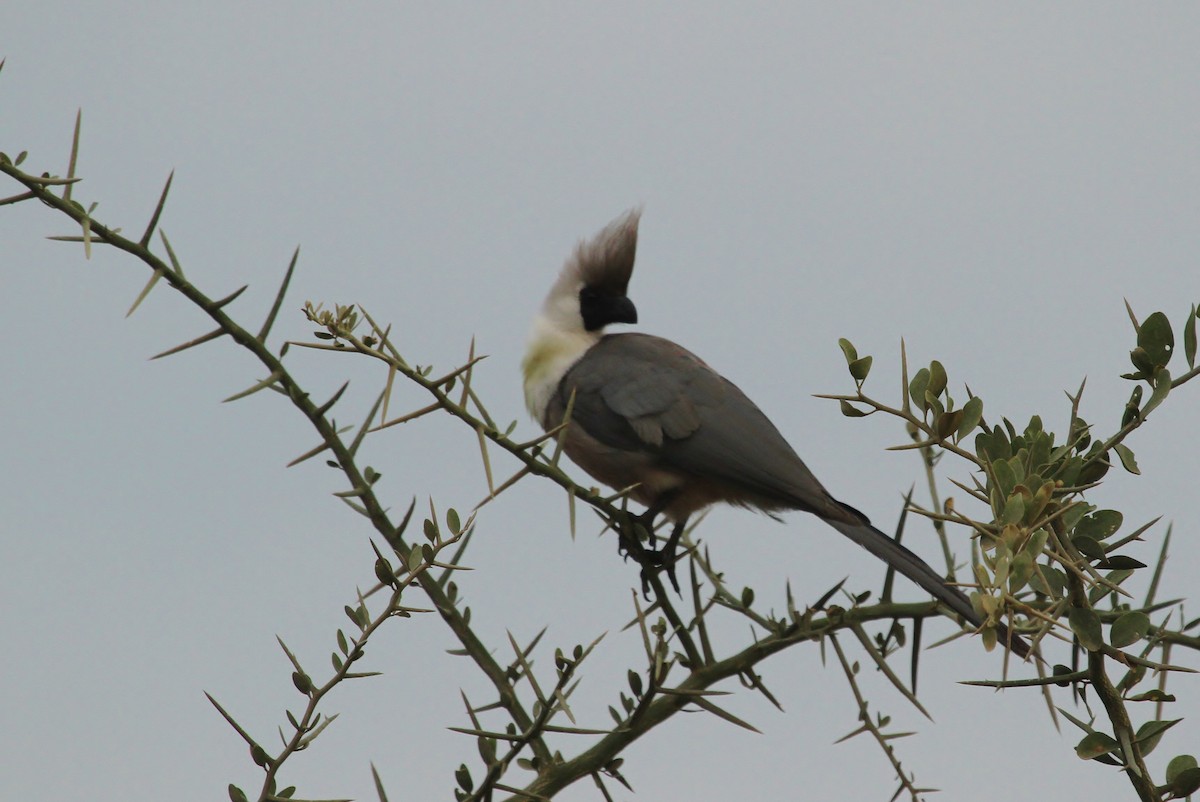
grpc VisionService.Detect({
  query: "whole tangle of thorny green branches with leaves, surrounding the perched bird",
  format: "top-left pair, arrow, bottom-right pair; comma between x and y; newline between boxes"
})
0,106 -> 1200,801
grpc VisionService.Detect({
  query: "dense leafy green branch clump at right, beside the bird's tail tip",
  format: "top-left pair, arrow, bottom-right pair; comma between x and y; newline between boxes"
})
822,316 -> 1200,802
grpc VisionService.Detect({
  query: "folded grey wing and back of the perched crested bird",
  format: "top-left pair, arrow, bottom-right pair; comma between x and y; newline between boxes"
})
556,334 -> 840,513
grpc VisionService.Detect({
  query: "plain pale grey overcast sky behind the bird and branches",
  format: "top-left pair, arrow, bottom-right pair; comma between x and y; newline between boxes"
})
0,6 -> 1200,802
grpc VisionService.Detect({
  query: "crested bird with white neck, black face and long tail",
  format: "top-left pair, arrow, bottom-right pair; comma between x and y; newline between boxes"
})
522,208 -> 1028,657
